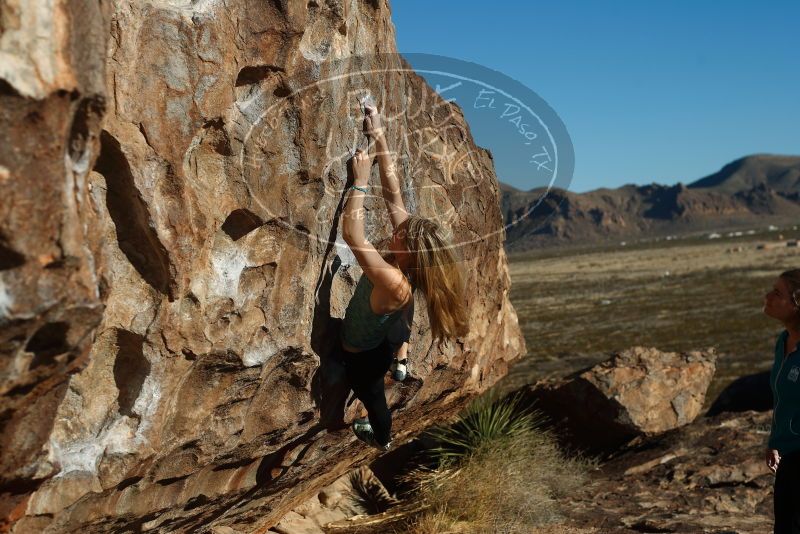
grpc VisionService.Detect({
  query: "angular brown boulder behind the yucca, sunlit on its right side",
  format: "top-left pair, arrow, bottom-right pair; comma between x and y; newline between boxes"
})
523,347 -> 716,452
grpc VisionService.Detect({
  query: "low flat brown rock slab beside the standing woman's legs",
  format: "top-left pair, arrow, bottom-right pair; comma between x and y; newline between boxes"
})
562,411 -> 774,534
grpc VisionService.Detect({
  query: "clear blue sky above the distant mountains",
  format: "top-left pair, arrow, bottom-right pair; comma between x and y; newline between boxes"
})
391,0 -> 800,192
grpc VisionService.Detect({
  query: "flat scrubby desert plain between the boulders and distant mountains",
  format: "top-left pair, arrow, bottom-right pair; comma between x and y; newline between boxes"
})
496,226 -> 800,408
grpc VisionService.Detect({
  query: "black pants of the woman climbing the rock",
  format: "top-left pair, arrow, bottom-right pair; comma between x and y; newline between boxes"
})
335,338 -> 393,445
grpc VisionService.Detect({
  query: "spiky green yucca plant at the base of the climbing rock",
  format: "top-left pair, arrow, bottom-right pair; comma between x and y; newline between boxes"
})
428,391 -> 546,466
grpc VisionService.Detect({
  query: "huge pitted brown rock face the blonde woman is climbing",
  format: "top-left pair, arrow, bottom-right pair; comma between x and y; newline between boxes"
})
0,0 -> 525,533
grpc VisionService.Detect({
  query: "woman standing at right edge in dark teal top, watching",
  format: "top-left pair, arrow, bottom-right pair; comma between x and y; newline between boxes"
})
763,269 -> 800,534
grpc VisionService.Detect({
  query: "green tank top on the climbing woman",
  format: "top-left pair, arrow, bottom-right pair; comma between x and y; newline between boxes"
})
342,274 -> 405,350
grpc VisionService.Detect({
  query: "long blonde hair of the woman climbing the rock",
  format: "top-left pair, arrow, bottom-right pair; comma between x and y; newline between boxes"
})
404,215 -> 469,343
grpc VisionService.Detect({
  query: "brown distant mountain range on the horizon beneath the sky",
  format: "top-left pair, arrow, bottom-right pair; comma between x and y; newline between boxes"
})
500,154 -> 800,252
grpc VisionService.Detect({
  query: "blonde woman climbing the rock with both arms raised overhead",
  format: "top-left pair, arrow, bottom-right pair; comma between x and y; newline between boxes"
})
336,104 -> 469,450
